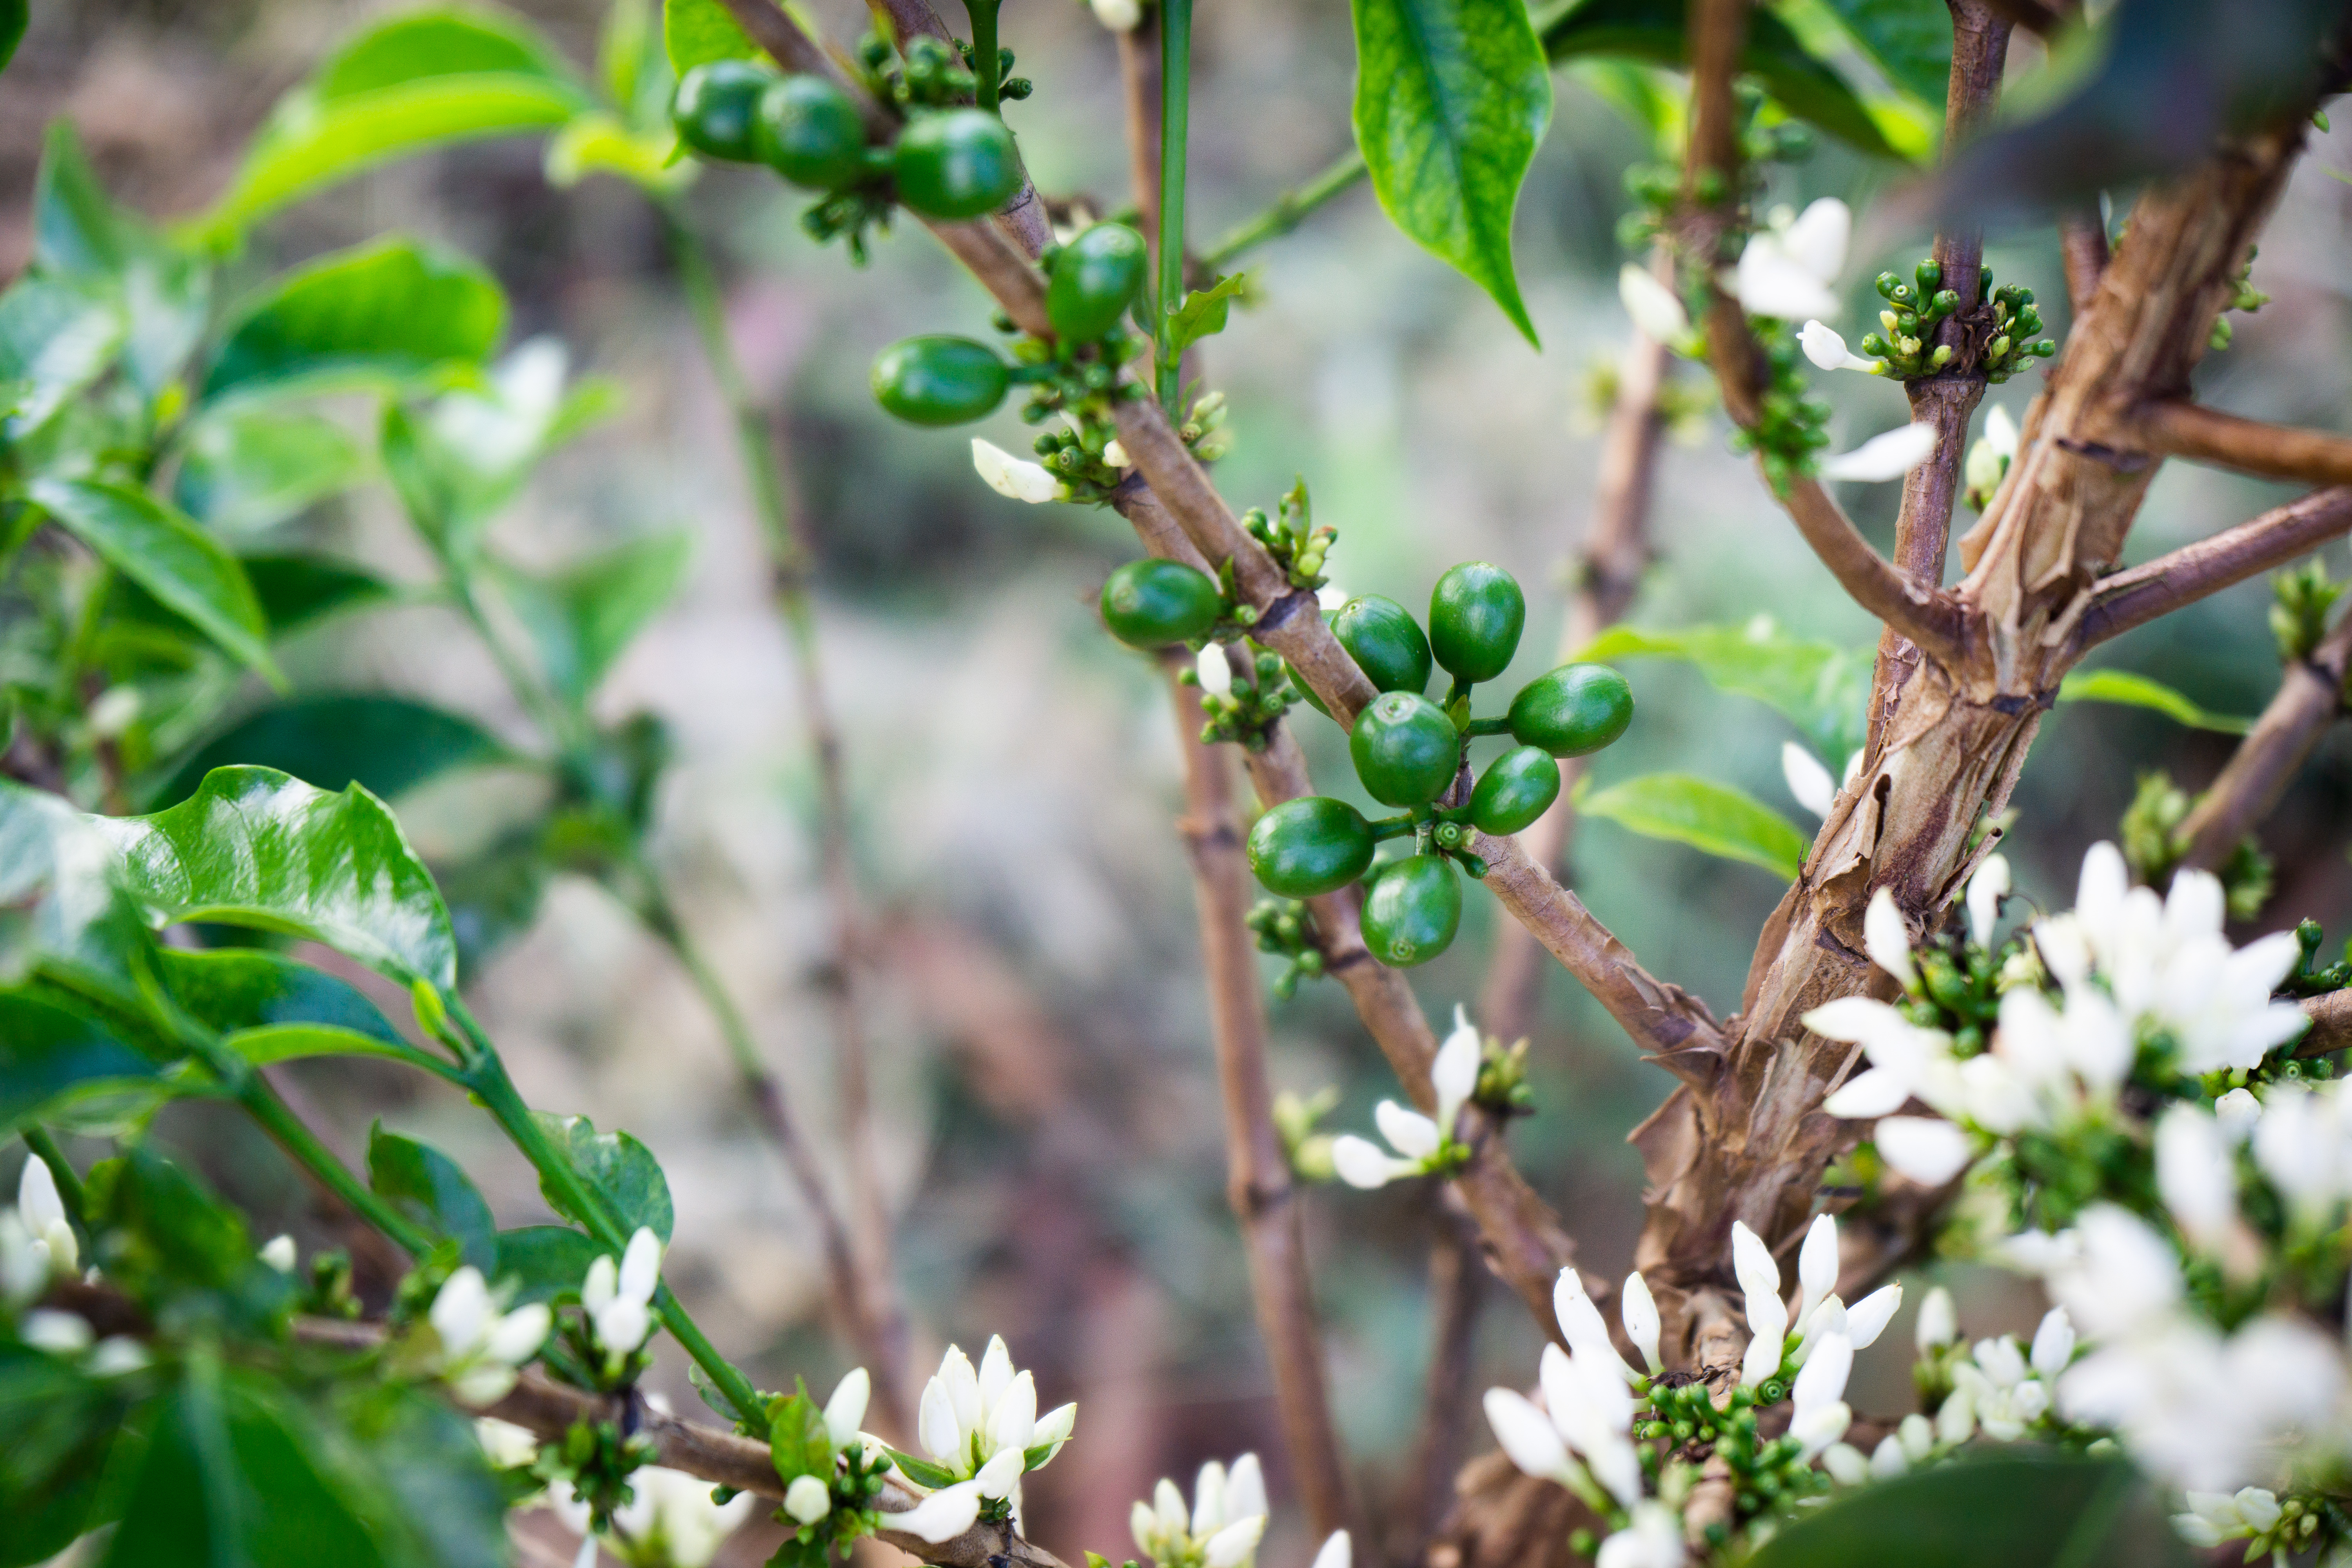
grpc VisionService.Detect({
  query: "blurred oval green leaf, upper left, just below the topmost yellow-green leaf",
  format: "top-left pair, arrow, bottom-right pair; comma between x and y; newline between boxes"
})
205,238 -> 506,397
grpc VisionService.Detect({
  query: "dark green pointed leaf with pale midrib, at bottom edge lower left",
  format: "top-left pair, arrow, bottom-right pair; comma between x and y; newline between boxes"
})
103,1356 -> 386,1568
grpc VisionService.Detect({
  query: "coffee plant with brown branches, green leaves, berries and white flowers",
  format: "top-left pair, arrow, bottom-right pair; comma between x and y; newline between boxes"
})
0,0 -> 2352,1568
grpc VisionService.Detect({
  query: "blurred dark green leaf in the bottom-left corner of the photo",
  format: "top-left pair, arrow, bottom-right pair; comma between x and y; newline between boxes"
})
0,1345 -> 125,1568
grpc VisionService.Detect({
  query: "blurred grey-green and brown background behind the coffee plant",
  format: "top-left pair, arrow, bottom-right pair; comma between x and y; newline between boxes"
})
0,0 -> 2352,1568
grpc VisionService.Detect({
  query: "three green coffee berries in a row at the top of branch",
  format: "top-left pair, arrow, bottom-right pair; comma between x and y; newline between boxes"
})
670,38 -> 1021,259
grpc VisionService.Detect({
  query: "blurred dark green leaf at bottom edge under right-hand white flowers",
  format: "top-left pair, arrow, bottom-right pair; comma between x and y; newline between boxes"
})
1750,1446 -> 2194,1568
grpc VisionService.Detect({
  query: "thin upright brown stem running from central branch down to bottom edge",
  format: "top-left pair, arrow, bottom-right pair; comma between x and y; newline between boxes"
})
1169,661 -> 1362,1537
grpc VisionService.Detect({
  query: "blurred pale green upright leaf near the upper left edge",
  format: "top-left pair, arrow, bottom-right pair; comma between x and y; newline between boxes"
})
33,120 -> 212,397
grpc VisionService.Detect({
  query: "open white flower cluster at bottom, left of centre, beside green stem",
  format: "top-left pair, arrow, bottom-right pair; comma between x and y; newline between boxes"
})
891,1338 -> 1077,1542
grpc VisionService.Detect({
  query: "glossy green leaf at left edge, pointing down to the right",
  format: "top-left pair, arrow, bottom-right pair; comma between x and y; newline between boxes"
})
28,479 -> 282,682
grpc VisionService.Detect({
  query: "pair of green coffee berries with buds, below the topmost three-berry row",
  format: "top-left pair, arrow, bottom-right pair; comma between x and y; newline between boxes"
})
873,221 -> 1145,435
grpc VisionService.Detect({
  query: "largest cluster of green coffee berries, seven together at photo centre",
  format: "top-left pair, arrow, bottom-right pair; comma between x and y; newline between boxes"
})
1249,562 -> 1632,969
